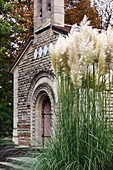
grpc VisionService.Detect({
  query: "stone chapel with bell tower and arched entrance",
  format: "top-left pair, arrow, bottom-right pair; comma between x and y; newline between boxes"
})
11,0 -> 71,147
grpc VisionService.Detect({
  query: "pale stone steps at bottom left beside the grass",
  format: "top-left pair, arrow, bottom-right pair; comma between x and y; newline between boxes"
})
0,157 -> 37,170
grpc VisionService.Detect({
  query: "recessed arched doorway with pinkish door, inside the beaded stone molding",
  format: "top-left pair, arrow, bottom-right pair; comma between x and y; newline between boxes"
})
31,90 -> 54,147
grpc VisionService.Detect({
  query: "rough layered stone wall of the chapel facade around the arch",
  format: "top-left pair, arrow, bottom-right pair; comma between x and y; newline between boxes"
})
14,27 -> 56,145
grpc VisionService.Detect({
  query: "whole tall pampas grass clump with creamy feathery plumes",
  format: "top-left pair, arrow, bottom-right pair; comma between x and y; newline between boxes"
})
32,17 -> 113,170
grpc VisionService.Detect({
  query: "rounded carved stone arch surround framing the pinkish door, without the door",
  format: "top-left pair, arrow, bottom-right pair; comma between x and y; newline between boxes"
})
28,73 -> 57,147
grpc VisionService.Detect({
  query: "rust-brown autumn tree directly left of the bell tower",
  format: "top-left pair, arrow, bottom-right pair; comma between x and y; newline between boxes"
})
11,0 -> 33,57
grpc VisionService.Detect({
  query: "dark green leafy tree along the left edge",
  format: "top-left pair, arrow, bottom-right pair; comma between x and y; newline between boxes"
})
0,0 -> 16,137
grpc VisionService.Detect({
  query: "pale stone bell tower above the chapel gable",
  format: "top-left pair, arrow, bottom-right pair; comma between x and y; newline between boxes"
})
34,0 -> 64,33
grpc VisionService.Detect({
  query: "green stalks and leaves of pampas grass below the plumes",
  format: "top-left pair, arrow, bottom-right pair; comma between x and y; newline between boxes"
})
32,67 -> 113,170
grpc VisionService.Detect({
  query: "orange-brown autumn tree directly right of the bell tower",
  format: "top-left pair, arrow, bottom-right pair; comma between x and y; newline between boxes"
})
65,0 -> 100,28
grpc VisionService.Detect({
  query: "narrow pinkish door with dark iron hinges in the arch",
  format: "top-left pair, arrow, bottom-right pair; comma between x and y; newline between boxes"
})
42,95 -> 51,146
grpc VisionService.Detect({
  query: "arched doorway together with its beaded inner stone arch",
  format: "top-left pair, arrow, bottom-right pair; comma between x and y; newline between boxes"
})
31,84 -> 56,147
